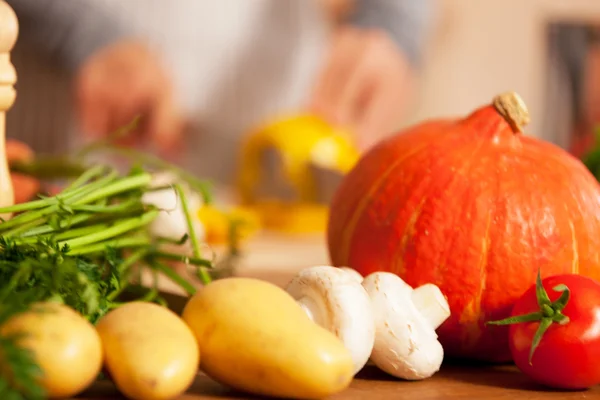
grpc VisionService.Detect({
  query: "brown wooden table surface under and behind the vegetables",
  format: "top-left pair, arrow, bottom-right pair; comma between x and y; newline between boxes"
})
78,235 -> 600,400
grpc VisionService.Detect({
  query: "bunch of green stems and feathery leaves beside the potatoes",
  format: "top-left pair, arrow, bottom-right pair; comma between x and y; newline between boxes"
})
0,123 -> 223,400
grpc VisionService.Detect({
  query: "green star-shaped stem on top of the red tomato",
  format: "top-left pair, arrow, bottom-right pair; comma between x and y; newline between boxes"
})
486,269 -> 571,365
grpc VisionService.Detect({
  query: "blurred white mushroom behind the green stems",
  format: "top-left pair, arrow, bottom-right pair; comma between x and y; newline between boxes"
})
142,172 -> 204,240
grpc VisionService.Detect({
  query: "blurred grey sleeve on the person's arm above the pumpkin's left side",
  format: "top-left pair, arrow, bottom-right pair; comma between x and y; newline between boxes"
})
348,0 -> 434,65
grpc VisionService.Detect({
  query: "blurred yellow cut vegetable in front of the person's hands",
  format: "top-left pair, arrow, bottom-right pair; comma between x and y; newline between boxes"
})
237,114 -> 360,233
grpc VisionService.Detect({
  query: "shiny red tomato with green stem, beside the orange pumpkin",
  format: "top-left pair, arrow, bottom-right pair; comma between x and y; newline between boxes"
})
488,274 -> 600,389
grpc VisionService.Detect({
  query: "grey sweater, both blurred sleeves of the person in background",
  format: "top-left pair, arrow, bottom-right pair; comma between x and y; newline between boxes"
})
7,0 -> 432,69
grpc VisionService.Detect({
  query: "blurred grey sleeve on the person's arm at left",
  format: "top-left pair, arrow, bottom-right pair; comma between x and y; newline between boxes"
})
6,0 -> 130,70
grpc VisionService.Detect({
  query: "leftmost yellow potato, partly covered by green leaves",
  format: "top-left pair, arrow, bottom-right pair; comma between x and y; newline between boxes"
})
1,303 -> 102,398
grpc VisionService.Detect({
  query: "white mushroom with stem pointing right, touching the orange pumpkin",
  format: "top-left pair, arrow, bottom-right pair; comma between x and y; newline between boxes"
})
362,272 -> 450,380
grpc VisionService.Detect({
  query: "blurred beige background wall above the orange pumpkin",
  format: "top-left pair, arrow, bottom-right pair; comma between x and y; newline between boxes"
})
403,0 -> 600,147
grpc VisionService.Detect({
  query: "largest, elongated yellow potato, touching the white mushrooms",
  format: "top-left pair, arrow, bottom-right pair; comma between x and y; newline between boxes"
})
183,278 -> 353,399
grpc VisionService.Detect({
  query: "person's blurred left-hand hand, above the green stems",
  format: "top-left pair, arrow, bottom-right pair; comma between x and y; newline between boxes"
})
75,41 -> 184,151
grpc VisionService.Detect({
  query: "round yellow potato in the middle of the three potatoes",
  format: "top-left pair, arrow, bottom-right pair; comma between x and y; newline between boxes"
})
96,302 -> 200,400
